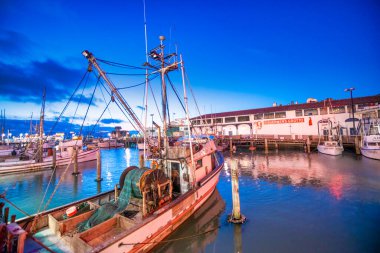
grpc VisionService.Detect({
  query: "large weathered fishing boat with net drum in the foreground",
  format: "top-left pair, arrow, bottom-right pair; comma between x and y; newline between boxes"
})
0,36 -> 224,253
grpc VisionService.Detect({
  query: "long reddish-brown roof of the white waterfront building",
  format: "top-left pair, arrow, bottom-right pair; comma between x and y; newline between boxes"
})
192,95 -> 380,119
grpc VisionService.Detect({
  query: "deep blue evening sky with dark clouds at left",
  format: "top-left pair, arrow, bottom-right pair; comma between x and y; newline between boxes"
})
0,0 -> 380,130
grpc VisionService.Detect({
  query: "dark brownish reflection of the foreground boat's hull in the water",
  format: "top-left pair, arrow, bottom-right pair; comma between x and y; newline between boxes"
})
154,189 -> 226,253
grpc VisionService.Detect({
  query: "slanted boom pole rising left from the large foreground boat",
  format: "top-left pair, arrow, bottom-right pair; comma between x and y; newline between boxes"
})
82,50 -> 146,136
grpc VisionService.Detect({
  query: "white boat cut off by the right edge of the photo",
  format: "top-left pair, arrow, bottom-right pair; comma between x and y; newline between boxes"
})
360,118 -> 380,160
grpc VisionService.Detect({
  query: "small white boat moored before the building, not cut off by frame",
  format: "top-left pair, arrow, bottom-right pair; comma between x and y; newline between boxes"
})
317,119 -> 344,156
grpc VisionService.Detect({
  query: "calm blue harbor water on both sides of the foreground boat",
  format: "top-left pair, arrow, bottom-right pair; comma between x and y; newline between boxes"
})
0,148 -> 380,253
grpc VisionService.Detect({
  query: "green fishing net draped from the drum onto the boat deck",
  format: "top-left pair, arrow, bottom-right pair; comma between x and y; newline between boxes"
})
78,168 -> 146,232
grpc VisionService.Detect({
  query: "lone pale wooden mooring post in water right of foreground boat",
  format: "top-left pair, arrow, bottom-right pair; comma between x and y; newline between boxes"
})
228,159 -> 246,224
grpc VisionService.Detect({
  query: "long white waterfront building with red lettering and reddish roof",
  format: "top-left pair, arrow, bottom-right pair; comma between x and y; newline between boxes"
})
191,95 -> 380,139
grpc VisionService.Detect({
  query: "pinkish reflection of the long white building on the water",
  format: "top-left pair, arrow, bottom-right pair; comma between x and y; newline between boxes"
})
225,152 -> 380,200
